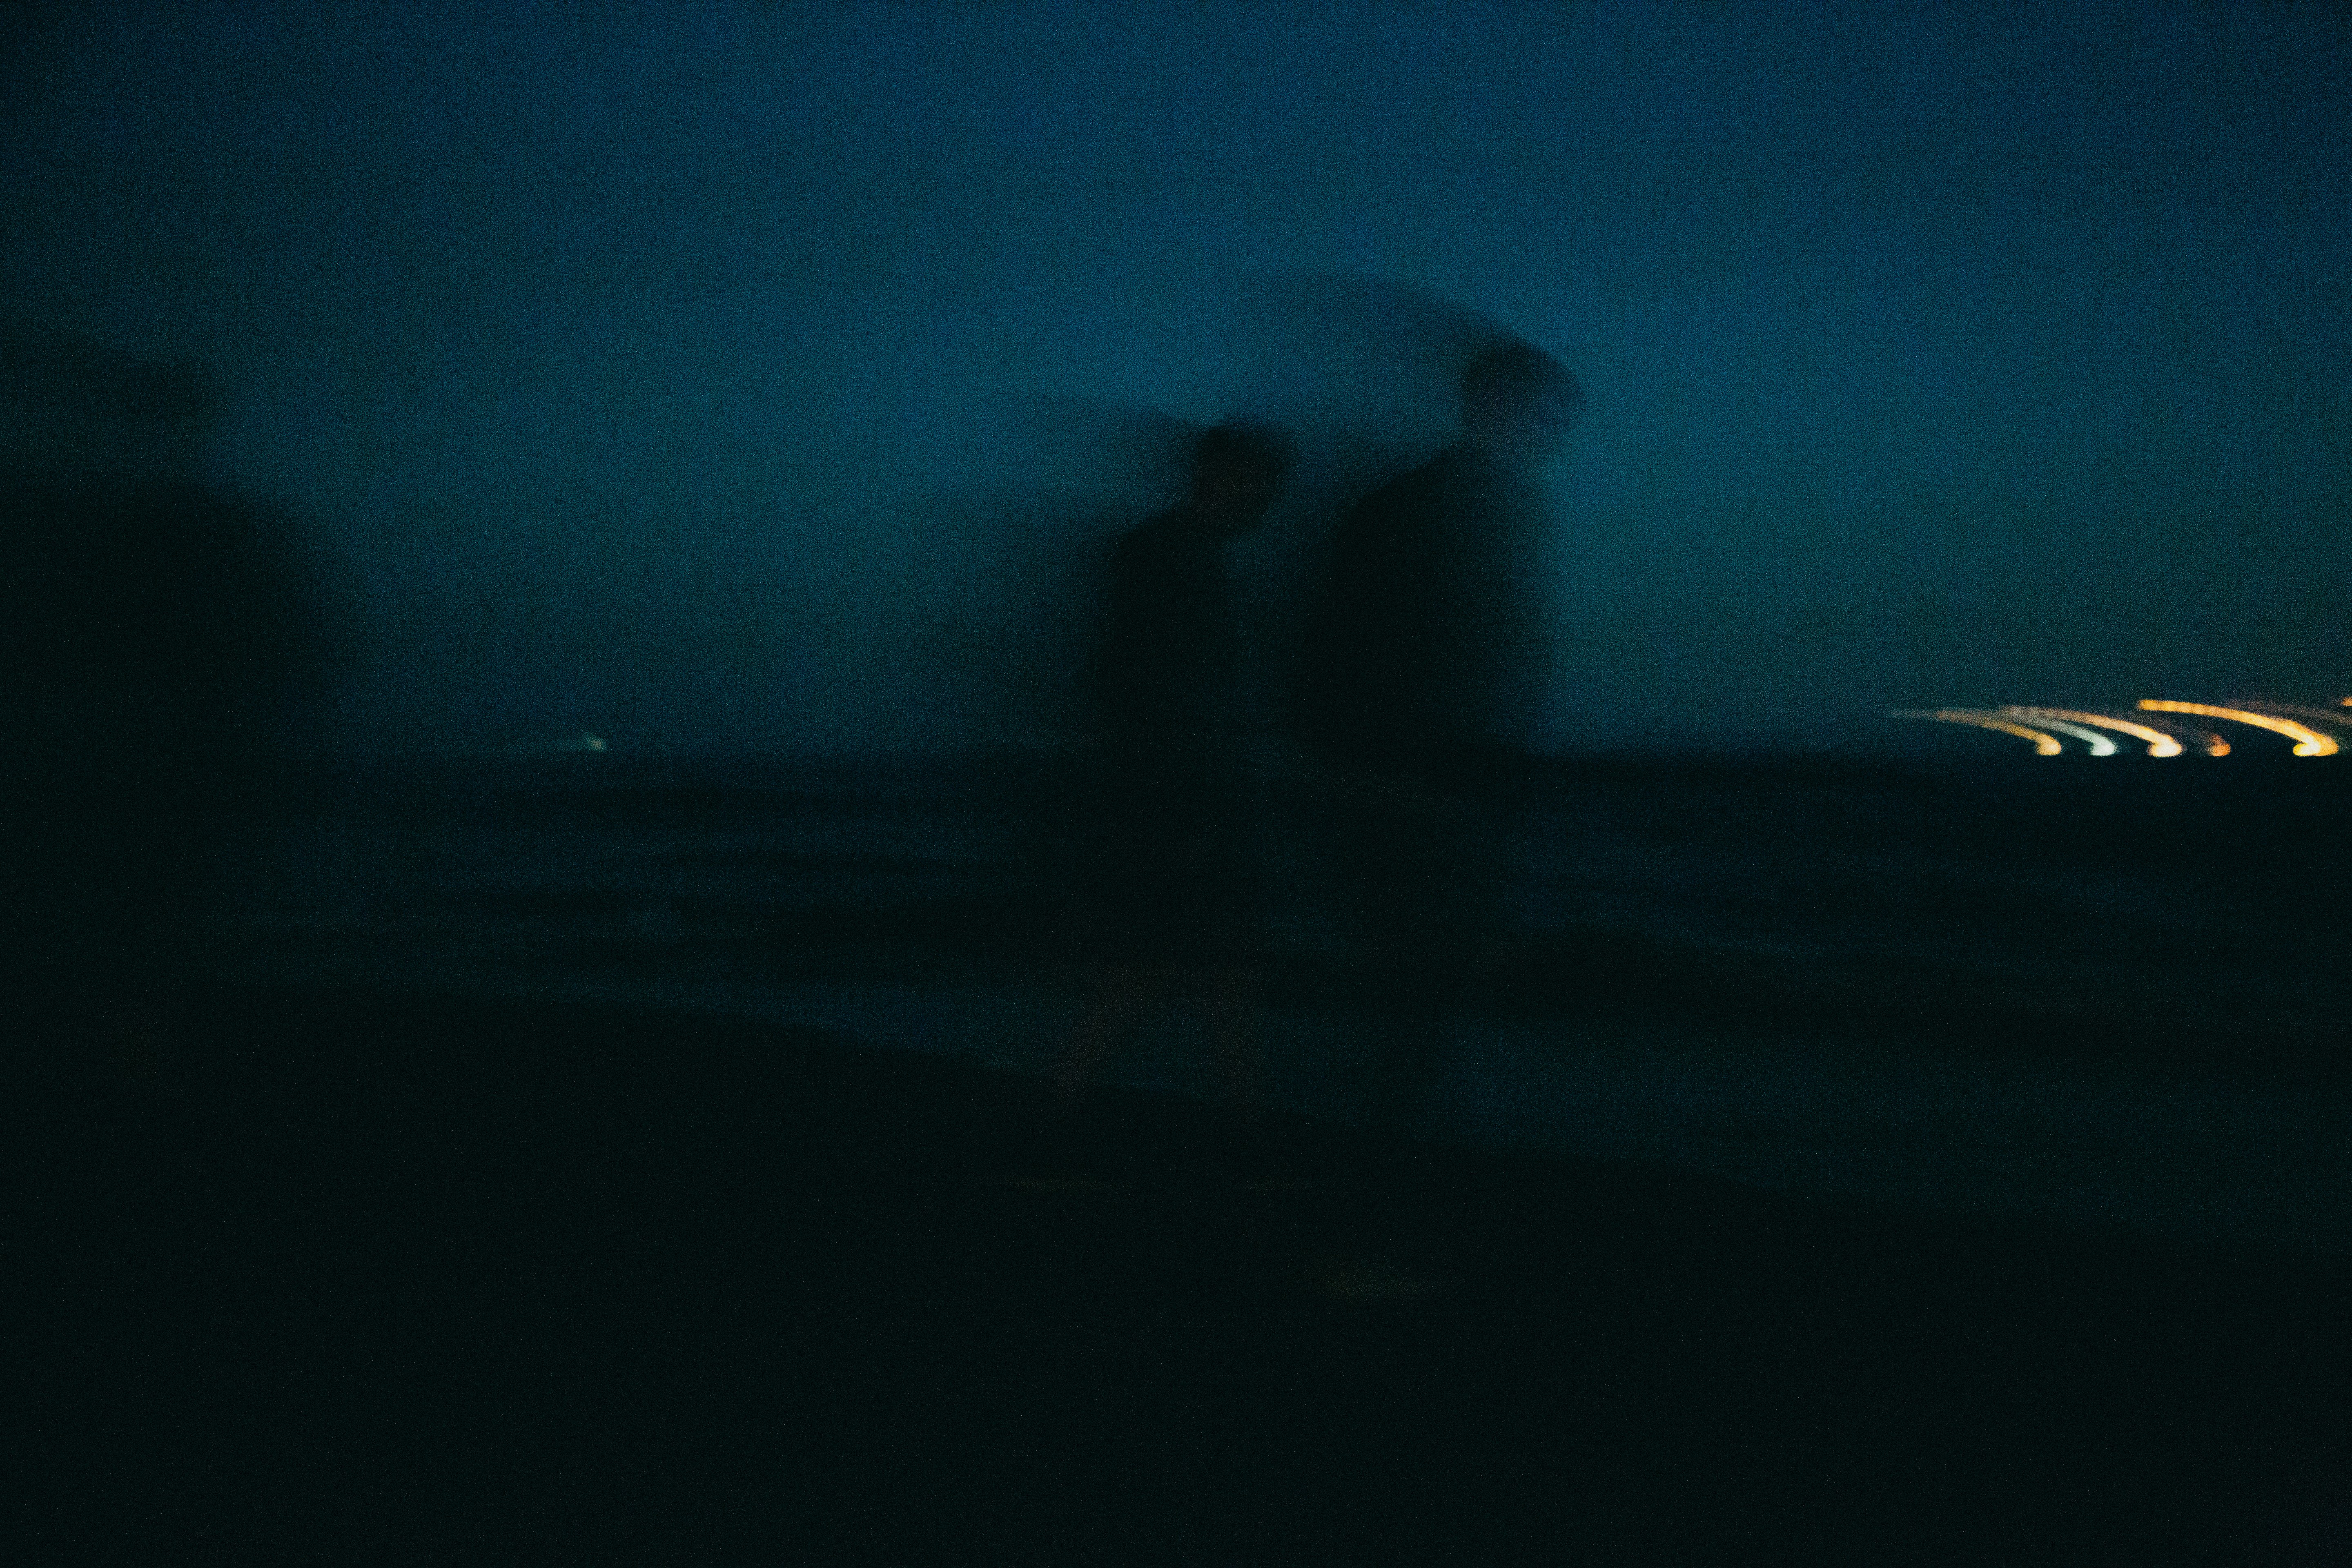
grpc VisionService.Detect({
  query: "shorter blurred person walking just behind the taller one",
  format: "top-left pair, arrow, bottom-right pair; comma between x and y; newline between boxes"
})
1058,423 -> 1294,1166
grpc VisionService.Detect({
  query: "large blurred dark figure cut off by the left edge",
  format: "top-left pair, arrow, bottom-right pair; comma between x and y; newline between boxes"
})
0,343 -> 334,1069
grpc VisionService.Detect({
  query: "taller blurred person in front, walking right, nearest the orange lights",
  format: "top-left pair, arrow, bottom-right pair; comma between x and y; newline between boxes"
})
1298,341 -> 1583,1278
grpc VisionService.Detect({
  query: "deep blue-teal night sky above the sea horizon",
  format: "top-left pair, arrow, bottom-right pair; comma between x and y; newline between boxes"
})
0,0 -> 2352,752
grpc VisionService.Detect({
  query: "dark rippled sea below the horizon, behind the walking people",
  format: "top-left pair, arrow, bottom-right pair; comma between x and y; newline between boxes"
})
207,752 -> 2352,1253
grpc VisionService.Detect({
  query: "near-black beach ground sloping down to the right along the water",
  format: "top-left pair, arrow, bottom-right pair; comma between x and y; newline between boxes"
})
7,994 -> 2352,1563
